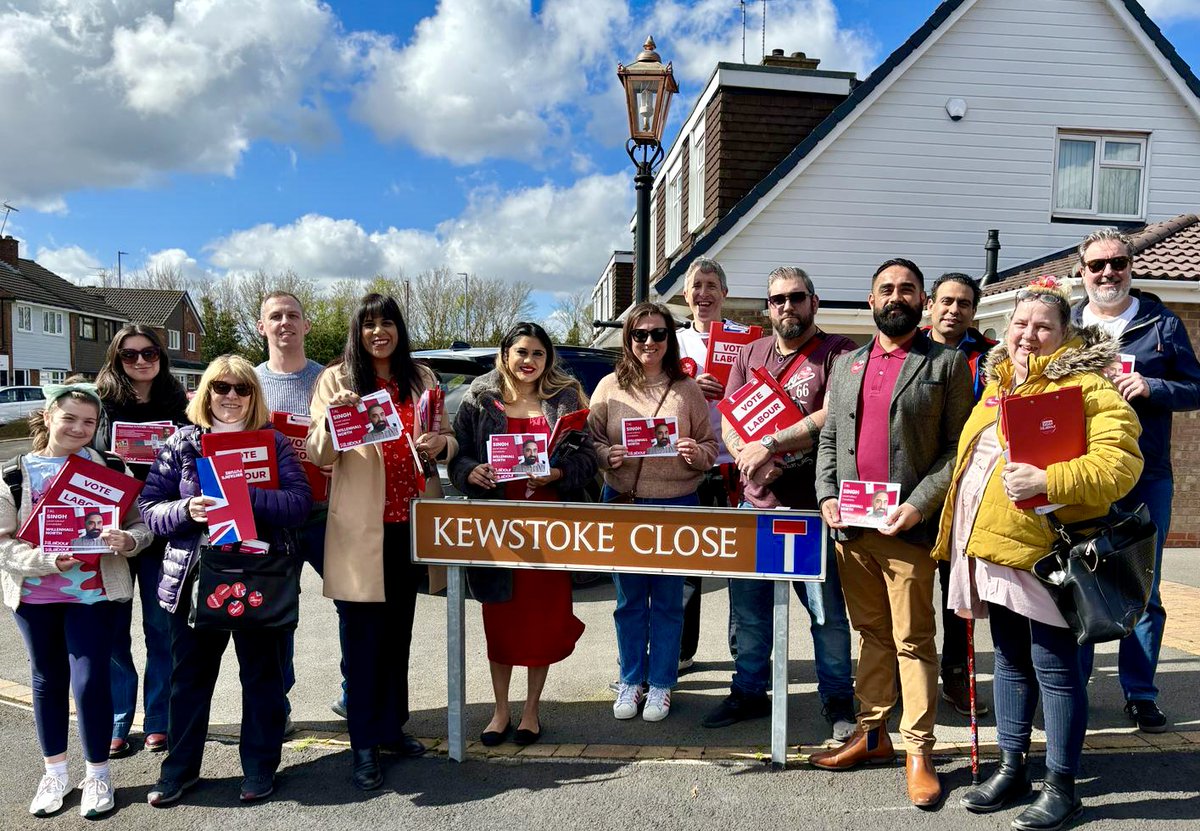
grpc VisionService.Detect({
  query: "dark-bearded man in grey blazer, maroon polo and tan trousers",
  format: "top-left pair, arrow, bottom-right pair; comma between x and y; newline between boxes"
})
809,259 -> 974,808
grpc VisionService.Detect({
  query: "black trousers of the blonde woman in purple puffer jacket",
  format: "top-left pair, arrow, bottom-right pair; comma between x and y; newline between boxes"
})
161,603 -> 292,782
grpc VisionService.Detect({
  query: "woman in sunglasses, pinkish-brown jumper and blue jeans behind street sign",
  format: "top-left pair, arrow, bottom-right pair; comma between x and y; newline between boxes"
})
588,303 -> 716,722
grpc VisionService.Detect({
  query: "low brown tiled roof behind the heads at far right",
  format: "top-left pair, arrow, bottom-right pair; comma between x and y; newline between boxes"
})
983,214 -> 1200,294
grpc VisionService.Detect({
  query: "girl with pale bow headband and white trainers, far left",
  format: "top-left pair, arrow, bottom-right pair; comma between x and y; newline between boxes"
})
0,379 -> 152,818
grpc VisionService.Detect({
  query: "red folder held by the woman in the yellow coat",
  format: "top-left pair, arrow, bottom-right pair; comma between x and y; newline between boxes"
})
1000,387 -> 1087,510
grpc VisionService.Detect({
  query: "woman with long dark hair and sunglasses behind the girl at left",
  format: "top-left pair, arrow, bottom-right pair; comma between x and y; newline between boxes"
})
92,323 -> 187,759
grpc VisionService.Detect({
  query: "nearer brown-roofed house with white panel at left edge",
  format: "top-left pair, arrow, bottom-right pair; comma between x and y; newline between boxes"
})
0,237 -> 128,387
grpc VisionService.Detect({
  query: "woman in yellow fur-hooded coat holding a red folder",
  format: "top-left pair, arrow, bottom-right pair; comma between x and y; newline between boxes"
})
934,277 -> 1142,831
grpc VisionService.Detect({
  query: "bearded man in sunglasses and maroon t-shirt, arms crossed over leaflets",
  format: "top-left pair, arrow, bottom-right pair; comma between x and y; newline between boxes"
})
702,267 -> 854,741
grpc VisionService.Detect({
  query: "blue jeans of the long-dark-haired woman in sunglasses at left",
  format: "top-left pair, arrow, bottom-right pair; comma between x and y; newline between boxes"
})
110,540 -> 170,740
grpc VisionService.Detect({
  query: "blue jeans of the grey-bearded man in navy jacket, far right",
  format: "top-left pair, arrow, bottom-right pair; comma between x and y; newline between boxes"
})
1081,479 -> 1175,701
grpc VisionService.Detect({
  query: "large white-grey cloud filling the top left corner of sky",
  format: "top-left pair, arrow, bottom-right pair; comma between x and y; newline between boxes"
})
0,0 -> 350,208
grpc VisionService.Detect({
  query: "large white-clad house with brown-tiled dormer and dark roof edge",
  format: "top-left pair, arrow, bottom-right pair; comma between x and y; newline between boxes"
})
598,0 -> 1200,345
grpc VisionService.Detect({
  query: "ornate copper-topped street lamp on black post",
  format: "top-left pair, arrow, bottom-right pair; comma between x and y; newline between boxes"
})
617,37 -> 679,303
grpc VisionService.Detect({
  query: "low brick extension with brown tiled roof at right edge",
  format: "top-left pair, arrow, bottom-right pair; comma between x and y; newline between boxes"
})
977,214 -> 1200,548
